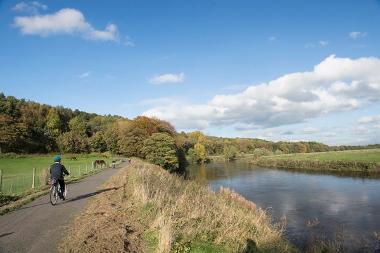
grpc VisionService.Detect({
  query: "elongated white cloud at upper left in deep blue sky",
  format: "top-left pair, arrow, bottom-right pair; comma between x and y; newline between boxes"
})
14,8 -> 119,41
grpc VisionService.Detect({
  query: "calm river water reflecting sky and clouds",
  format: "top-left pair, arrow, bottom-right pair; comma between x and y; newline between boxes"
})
189,162 -> 380,252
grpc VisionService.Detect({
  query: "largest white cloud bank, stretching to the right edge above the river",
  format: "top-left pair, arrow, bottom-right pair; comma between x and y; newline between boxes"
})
144,55 -> 380,130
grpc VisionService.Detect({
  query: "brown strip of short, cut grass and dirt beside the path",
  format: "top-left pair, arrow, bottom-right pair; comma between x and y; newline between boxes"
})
59,167 -> 144,253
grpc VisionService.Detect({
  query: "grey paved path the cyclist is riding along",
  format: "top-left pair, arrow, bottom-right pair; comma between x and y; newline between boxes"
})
0,164 -> 126,253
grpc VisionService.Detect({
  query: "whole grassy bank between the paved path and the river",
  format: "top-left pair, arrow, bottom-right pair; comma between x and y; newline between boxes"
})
60,160 -> 294,252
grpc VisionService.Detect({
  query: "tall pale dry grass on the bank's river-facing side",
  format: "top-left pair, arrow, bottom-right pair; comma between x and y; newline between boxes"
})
127,161 -> 293,252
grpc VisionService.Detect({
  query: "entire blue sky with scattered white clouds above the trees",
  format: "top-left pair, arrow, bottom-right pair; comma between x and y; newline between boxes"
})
0,0 -> 380,145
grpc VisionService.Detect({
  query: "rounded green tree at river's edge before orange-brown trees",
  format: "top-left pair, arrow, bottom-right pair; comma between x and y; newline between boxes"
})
142,133 -> 179,171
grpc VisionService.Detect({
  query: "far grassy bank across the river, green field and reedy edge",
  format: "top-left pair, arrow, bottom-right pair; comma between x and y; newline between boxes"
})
251,149 -> 380,174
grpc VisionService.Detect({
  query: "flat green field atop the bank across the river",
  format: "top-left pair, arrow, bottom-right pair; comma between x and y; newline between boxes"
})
267,149 -> 380,163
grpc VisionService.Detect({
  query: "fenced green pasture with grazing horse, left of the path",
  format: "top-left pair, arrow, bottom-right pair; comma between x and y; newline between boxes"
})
0,154 -> 112,194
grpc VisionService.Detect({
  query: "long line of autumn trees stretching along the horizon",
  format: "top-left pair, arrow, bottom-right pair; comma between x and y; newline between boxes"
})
0,93 -> 378,170
